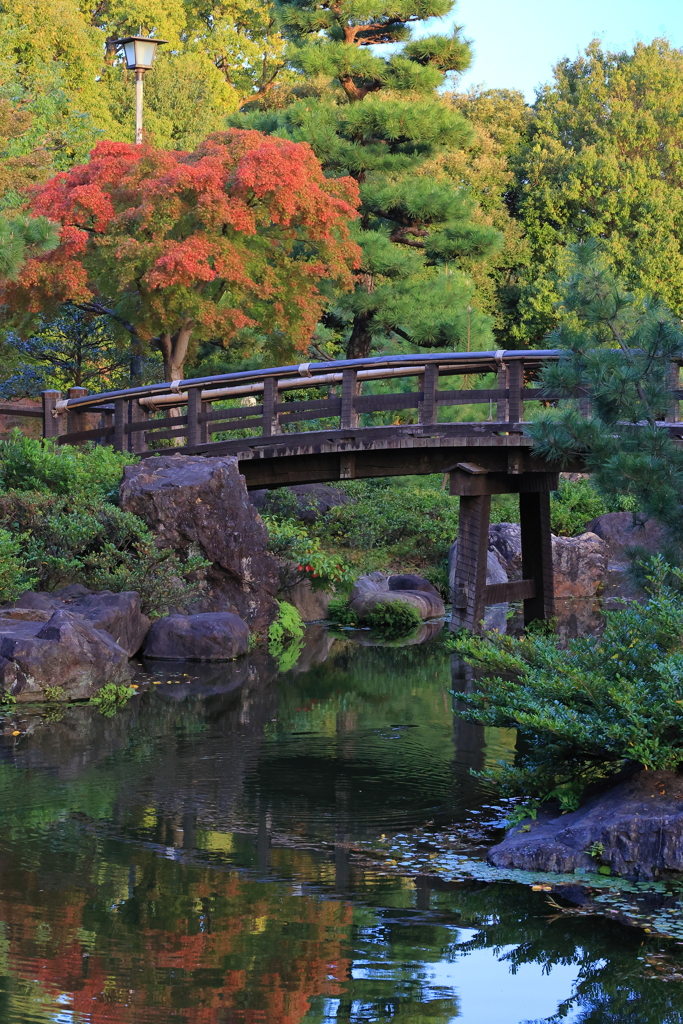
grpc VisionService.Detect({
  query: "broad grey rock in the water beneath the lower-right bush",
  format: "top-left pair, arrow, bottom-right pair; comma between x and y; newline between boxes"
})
488,771 -> 683,879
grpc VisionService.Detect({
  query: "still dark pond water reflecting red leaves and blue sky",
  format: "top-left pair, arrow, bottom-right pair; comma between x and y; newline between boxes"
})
0,628 -> 683,1024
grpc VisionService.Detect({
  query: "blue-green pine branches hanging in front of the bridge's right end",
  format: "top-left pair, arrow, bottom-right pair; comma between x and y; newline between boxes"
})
528,242 -> 683,531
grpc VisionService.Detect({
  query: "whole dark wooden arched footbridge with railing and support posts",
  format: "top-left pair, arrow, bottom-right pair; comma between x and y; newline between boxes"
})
28,350 -> 683,629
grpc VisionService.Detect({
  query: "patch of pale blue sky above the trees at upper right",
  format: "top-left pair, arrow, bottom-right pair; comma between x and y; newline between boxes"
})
421,0 -> 683,102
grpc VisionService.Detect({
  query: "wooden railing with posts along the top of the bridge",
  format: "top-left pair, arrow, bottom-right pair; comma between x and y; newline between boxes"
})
37,349 -> 678,454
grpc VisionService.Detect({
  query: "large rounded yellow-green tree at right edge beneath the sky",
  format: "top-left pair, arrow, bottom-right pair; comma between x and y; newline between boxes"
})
515,39 -> 683,344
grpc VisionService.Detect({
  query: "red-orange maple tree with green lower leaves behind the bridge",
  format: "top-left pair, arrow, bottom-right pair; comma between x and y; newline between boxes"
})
2,129 -> 360,381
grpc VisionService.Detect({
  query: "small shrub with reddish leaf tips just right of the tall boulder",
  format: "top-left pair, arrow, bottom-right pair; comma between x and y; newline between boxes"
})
263,512 -> 353,590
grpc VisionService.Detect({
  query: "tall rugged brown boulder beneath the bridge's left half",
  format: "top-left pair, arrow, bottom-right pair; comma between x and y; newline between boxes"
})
120,455 -> 278,630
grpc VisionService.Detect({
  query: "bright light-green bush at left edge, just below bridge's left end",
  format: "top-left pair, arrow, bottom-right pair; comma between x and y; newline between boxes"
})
0,430 -> 138,498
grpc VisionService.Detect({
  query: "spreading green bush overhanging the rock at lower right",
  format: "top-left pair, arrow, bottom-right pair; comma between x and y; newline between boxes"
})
449,558 -> 683,809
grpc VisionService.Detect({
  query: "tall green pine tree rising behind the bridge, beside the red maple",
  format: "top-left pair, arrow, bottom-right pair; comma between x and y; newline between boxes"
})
231,0 -> 502,358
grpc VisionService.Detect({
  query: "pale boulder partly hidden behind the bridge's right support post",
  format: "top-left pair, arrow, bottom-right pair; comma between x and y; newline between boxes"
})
488,513 -> 610,598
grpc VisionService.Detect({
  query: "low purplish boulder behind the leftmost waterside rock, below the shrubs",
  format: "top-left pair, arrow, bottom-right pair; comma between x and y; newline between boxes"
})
14,584 -> 151,656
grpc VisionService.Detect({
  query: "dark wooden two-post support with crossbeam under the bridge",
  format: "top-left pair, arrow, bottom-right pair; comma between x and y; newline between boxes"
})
451,460 -> 559,633
